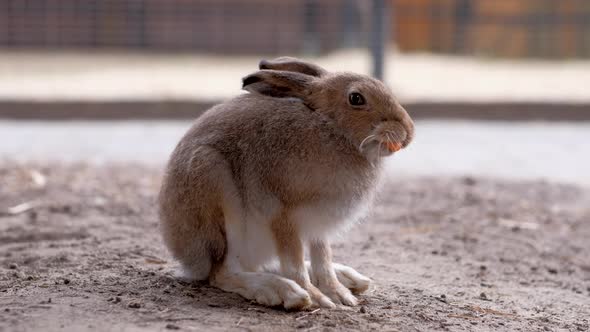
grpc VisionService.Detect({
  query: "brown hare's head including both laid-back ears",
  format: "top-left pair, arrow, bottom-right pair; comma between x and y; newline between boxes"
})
243,57 -> 414,158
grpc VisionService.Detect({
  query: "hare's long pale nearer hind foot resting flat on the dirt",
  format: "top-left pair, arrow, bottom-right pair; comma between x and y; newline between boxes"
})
210,267 -> 312,310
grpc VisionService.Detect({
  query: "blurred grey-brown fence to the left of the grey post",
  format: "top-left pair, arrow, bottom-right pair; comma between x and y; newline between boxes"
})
0,0 -> 368,54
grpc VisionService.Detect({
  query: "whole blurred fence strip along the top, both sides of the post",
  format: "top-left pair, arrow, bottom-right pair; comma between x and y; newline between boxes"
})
0,0 -> 590,57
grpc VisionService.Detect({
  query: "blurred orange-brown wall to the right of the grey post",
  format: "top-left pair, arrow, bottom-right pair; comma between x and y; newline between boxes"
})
392,0 -> 590,58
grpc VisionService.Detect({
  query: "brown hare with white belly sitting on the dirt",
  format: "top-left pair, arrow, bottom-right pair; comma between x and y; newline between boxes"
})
159,57 -> 414,310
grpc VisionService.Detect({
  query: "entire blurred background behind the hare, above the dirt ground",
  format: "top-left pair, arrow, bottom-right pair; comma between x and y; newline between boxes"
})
0,0 -> 590,183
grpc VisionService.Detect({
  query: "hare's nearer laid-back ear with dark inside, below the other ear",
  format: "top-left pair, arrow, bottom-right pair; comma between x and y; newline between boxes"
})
242,70 -> 314,99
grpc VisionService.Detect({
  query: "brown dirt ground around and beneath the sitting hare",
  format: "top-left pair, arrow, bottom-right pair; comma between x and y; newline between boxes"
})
0,161 -> 590,331
